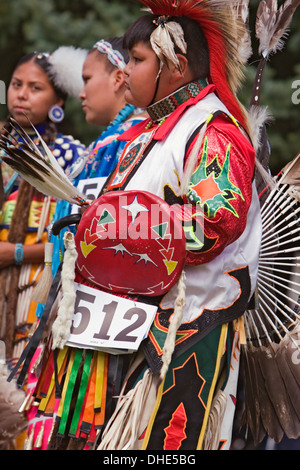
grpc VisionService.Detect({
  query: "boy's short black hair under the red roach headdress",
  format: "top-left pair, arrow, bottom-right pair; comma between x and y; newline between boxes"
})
123,14 -> 209,78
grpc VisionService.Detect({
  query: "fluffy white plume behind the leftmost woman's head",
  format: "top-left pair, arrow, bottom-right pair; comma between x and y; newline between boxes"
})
49,46 -> 87,97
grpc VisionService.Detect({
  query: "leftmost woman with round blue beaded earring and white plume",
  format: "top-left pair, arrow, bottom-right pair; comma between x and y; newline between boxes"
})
0,47 -> 86,448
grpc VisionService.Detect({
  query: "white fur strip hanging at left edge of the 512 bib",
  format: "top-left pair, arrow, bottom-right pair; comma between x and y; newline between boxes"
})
52,232 -> 77,349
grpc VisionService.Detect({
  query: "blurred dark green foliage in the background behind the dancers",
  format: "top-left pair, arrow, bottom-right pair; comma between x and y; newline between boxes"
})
0,0 -> 300,173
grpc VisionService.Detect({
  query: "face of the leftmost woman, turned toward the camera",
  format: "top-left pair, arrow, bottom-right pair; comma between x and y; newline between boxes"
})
7,60 -> 63,128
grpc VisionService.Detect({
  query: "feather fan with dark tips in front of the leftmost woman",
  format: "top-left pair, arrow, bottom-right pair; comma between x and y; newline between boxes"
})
0,118 -> 88,206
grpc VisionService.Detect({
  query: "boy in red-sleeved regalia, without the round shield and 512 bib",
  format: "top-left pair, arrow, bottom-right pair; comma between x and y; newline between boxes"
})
92,0 -> 261,450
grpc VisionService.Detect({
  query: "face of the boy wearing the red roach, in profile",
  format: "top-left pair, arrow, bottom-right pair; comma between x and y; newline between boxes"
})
124,42 -> 166,108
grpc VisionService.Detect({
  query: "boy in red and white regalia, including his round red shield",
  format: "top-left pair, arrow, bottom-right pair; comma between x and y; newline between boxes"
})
10,0 -> 261,450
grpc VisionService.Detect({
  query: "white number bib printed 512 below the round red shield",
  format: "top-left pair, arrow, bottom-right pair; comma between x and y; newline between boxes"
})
66,283 -> 157,354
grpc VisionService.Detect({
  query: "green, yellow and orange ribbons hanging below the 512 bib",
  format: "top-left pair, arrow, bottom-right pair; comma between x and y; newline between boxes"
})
33,346 -> 114,445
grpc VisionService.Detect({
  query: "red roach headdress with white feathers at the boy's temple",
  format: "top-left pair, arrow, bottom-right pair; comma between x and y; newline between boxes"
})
140,0 -> 248,130
